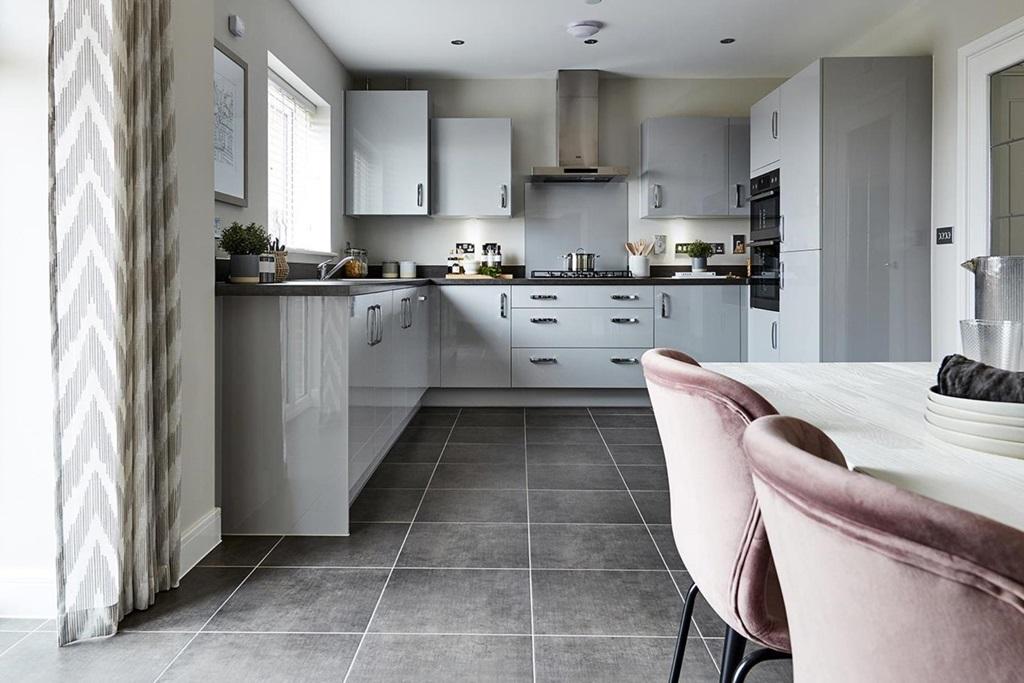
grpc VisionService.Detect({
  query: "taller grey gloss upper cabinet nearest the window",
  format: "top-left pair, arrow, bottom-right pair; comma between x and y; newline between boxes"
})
345,90 -> 430,216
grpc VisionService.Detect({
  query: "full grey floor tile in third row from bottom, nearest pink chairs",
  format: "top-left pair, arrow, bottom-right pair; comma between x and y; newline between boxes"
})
530,524 -> 665,569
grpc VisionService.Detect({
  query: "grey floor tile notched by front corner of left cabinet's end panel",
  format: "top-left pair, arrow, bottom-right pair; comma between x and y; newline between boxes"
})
262,523 -> 409,568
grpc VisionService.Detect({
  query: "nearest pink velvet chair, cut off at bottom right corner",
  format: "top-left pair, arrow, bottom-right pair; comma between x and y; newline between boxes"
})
743,417 -> 1024,683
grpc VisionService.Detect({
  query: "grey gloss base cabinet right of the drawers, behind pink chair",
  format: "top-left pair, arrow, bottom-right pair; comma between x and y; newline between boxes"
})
654,285 -> 745,362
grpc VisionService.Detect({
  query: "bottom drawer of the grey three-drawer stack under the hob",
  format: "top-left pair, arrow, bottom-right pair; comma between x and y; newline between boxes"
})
512,348 -> 647,389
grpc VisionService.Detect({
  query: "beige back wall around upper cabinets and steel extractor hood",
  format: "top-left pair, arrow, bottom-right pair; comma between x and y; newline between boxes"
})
353,78 -> 780,265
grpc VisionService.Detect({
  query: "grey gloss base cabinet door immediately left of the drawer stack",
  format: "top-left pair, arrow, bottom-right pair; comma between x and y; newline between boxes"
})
438,285 -> 512,388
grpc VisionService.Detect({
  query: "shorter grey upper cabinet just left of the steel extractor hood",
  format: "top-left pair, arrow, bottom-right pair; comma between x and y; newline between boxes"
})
430,119 -> 512,216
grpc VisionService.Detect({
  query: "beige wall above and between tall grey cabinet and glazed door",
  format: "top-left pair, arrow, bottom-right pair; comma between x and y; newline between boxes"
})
837,0 -> 1024,358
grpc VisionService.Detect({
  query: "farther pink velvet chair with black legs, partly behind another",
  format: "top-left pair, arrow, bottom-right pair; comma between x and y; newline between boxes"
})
642,349 -> 790,681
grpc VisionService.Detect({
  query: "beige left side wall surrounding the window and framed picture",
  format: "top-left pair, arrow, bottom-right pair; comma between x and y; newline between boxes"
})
211,0 -> 350,251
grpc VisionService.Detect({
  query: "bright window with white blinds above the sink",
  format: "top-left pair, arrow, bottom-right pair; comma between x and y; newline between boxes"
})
267,60 -> 331,252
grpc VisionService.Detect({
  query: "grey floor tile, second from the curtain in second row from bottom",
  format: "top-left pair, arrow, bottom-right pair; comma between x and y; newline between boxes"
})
206,568 -> 388,632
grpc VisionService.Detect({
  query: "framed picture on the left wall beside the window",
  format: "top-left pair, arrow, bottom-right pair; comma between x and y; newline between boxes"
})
213,41 -> 249,206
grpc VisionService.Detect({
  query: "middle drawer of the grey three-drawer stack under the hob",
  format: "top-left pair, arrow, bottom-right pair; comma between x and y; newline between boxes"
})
512,308 -> 654,348
